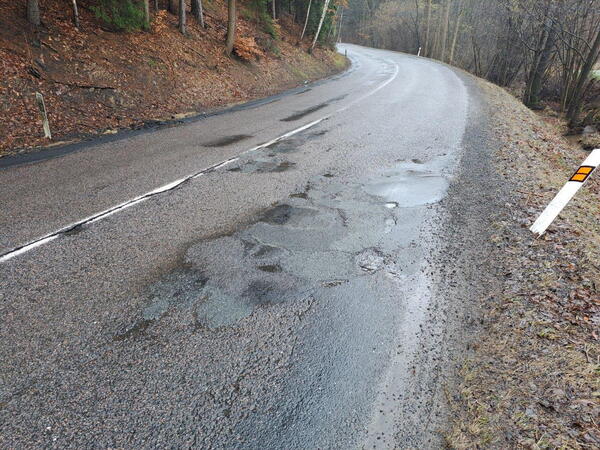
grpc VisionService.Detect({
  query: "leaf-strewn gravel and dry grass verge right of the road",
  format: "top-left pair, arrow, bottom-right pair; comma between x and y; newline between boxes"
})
446,77 -> 600,449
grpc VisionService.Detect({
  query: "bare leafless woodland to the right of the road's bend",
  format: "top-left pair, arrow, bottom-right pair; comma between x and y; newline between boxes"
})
342,0 -> 600,131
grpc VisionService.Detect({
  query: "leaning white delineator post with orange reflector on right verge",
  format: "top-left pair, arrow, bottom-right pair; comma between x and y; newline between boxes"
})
529,149 -> 600,236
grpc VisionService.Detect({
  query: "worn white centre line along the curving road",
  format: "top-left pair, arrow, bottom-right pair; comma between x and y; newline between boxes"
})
0,56 -> 399,263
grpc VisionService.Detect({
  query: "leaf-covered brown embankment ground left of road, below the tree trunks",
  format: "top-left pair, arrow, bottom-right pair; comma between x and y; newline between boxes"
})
0,0 -> 346,156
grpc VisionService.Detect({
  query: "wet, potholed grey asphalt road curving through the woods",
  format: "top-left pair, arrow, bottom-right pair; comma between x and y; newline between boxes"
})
0,45 -> 492,449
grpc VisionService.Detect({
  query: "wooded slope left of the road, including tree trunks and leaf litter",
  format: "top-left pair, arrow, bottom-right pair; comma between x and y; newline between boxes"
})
0,0 -> 346,155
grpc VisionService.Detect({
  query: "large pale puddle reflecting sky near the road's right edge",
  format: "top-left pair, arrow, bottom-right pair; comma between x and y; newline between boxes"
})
364,162 -> 449,208
